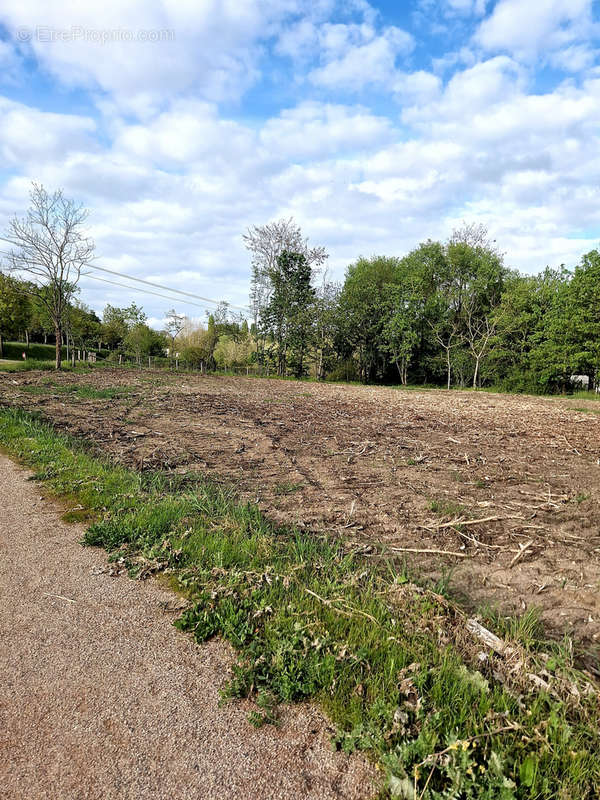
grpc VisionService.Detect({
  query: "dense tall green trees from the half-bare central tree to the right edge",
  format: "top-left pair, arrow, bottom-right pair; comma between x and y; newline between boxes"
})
245,220 -> 600,393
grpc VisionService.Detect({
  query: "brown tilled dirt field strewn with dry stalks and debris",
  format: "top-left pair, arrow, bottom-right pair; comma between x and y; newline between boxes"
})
0,369 -> 600,655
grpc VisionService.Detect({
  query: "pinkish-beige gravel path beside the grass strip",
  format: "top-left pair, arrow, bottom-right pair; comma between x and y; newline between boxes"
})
0,456 -> 373,800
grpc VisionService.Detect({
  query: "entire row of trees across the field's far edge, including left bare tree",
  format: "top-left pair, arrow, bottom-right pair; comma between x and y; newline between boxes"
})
0,184 -> 600,392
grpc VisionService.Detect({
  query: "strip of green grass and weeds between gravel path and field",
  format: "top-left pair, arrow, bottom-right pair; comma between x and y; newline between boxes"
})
0,409 -> 600,800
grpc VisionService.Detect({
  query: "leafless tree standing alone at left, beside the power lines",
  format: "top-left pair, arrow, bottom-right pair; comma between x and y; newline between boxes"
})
0,183 -> 94,369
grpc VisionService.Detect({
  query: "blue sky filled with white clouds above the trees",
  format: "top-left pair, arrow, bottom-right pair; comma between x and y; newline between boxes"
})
0,0 -> 600,325
